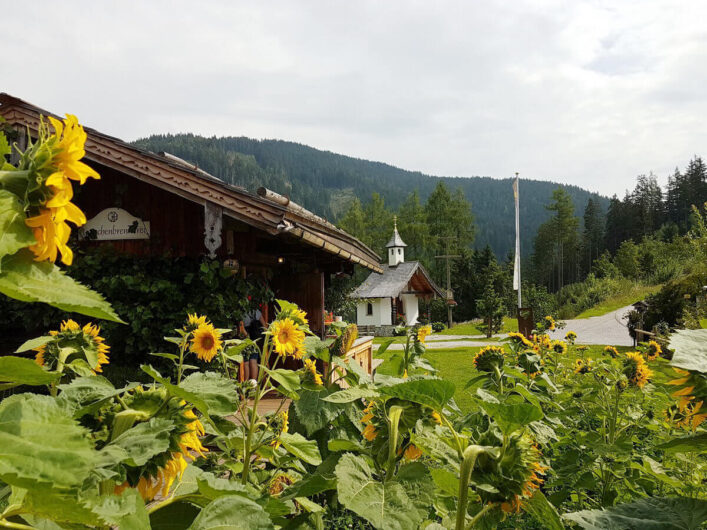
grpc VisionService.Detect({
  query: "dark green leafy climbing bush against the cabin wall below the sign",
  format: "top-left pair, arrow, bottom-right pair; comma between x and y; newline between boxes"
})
0,247 -> 272,367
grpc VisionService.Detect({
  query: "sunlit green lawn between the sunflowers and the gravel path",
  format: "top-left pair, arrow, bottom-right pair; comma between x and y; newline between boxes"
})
425,345 -> 674,411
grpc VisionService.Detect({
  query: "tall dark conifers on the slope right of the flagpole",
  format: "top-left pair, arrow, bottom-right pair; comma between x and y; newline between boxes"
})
531,156 -> 707,292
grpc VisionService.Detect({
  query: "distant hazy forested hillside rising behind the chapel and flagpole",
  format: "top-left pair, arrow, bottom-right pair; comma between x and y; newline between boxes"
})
134,134 -> 608,258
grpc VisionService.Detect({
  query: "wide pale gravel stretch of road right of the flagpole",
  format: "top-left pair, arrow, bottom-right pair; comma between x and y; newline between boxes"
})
550,305 -> 633,346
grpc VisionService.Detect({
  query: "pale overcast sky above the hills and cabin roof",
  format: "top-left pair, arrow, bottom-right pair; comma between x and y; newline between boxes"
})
0,0 -> 707,196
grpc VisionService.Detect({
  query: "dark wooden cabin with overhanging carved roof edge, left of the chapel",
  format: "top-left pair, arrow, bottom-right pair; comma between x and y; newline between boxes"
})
0,94 -> 382,340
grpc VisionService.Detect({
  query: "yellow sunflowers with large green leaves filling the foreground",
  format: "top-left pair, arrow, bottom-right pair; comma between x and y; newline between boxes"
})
0,117 -> 707,530
